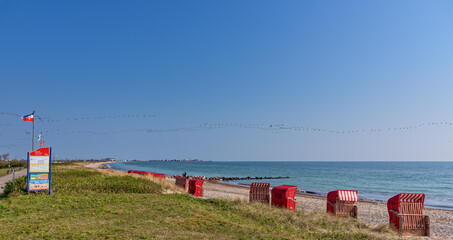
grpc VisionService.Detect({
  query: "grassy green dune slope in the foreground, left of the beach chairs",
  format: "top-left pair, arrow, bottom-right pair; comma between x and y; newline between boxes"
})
0,162 -> 395,239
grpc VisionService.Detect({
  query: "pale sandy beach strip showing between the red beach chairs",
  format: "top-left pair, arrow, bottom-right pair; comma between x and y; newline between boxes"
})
86,162 -> 453,239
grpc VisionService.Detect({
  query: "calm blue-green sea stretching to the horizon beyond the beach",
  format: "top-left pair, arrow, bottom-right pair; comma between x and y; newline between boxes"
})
111,161 -> 453,209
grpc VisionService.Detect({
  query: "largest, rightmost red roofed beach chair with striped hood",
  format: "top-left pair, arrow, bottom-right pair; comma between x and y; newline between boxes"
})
387,193 -> 430,237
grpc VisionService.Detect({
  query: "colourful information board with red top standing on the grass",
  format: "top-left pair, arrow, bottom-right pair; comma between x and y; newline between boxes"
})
27,147 -> 52,195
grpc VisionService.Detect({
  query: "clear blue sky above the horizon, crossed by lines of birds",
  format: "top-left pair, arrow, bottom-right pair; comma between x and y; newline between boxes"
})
0,0 -> 453,160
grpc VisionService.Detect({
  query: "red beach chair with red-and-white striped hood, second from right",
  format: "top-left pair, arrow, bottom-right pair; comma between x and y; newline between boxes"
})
327,190 -> 358,218
